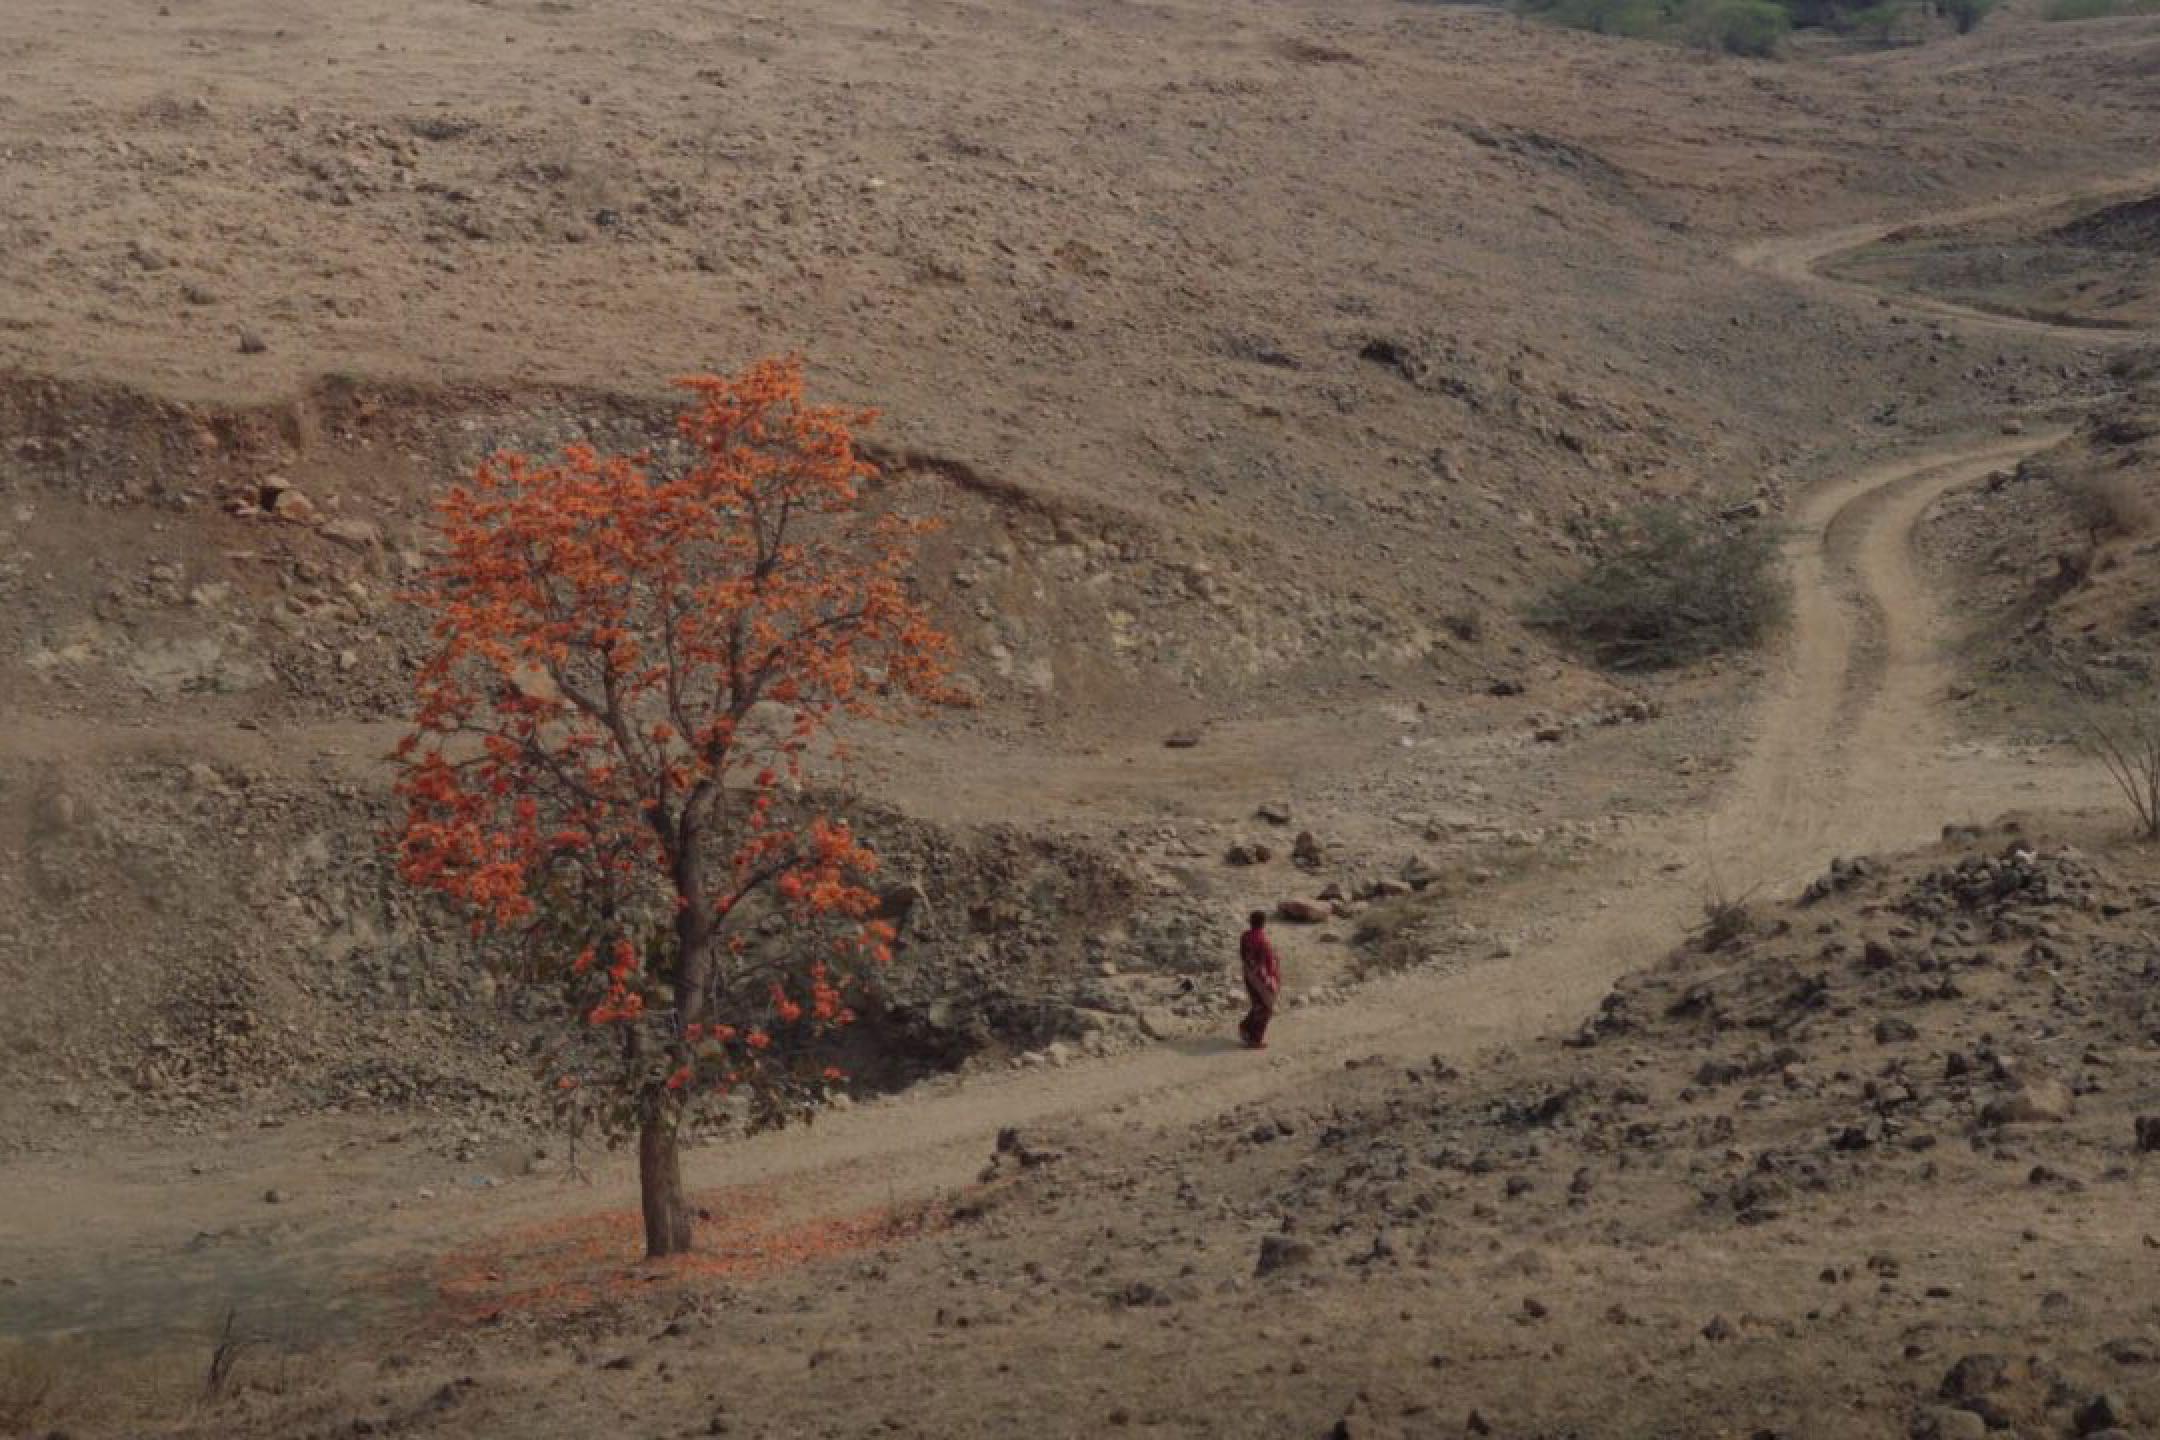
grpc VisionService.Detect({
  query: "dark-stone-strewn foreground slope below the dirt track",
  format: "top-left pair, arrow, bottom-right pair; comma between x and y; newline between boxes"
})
88,823 -> 2160,1438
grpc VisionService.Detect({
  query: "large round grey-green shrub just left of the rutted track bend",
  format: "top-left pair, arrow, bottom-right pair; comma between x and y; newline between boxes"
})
1529,505 -> 1786,669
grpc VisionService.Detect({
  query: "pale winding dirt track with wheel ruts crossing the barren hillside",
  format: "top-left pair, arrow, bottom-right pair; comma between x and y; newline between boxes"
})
0,191 -> 2134,1355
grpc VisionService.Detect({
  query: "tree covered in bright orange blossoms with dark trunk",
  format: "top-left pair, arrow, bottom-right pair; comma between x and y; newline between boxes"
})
395,361 -> 948,1256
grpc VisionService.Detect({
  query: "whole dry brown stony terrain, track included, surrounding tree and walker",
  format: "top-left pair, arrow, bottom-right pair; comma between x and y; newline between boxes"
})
0,0 -> 2160,1436
